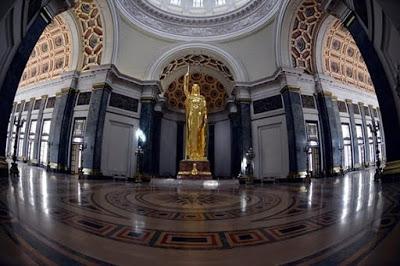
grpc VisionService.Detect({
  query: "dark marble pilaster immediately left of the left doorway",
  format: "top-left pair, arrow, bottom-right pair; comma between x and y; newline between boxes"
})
49,88 -> 77,172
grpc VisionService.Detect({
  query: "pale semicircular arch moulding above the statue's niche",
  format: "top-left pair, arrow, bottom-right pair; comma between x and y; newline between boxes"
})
146,43 -> 249,82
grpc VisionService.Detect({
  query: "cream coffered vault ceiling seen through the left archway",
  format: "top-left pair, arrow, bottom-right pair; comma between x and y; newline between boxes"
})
20,16 -> 72,86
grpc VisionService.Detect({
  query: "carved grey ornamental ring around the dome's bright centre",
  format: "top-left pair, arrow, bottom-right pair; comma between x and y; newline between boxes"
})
116,0 -> 280,41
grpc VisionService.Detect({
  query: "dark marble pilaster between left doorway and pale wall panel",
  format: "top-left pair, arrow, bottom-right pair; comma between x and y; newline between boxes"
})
82,83 -> 111,178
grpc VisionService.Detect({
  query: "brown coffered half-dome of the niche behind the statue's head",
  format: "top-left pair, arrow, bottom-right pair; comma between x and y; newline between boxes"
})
165,73 -> 228,113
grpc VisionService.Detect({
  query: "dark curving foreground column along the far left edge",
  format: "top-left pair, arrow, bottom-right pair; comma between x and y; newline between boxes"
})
0,13 -> 51,177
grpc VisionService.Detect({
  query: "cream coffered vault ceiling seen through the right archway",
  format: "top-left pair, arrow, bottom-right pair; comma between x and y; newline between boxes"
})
323,20 -> 375,92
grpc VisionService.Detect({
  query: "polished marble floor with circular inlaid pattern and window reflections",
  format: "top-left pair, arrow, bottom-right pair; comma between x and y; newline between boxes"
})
0,164 -> 400,266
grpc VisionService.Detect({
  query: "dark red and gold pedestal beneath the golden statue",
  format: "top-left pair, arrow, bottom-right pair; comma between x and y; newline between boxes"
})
177,160 -> 212,180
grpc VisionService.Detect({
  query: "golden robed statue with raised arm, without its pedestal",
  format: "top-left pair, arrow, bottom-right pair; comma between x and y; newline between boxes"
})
183,67 -> 207,160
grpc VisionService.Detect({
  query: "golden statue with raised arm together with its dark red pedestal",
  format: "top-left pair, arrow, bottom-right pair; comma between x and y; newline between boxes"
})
178,67 -> 211,179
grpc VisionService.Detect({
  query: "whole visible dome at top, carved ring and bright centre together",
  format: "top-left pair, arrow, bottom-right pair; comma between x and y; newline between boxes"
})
116,0 -> 280,41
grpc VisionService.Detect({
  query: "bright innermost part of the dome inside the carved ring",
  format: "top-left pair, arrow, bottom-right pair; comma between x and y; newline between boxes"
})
147,0 -> 250,17
